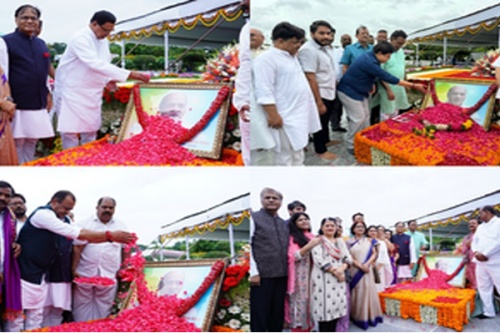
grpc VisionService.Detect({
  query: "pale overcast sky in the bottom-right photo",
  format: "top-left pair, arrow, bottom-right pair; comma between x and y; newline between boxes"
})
251,167 -> 500,234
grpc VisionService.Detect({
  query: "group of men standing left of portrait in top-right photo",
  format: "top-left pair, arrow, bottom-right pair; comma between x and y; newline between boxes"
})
251,20 -> 425,166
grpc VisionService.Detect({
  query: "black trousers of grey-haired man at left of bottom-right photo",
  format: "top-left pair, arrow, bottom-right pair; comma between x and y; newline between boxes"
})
250,276 -> 287,332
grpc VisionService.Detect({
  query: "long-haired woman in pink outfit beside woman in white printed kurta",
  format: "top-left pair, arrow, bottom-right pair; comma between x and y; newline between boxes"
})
285,213 -> 321,332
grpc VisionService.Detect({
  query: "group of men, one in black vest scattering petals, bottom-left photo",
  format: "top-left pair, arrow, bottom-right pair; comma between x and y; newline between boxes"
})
0,181 -> 135,332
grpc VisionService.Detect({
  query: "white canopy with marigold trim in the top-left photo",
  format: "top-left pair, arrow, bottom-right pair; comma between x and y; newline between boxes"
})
109,0 -> 245,67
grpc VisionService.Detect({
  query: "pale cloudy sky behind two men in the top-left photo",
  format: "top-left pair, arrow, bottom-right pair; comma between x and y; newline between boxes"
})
0,0 -> 180,43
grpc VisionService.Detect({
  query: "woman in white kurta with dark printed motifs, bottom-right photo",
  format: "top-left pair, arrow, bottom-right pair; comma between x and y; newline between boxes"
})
311,218 -> 351,332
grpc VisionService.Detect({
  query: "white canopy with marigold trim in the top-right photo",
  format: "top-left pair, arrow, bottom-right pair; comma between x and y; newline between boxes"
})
407,3 -> 500,62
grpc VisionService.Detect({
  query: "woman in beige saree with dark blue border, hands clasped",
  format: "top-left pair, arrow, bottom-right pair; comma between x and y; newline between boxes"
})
347,222 -> 382,330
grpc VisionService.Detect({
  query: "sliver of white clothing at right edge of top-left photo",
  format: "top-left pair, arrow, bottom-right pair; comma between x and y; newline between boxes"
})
233,22 -> 252,111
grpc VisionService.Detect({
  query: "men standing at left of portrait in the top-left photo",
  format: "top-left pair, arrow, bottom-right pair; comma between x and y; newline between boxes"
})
0,5 -> 149,165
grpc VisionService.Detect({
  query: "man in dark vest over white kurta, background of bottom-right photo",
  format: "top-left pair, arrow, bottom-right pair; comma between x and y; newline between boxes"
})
391,222 -> 417,283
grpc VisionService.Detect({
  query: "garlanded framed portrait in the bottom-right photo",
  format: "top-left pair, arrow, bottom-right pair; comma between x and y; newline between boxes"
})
417,254 -> 467,288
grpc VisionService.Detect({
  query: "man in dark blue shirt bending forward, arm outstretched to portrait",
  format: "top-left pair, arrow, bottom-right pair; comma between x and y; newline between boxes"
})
337,42 -> 426,154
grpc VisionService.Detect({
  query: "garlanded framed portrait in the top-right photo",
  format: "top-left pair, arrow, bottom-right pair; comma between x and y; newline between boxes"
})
422,78 -> 495,130
